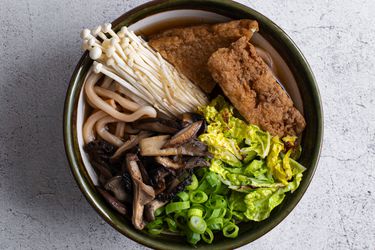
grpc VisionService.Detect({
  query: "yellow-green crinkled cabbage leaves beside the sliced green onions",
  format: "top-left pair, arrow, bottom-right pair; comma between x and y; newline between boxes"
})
199,96 -> 305,221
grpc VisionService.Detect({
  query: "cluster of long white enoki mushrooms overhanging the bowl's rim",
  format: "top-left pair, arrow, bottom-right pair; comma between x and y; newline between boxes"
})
81,24 -> 208,118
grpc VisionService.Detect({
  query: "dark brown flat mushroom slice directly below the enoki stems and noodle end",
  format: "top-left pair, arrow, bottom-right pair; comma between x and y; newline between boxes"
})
133,118 -> 181,134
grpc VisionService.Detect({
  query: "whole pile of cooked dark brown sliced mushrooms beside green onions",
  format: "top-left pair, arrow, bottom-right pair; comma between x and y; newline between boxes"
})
85,113 -> 211,230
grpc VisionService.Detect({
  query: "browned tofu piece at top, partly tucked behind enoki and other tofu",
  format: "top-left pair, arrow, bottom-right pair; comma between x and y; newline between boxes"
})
149,19 -> 258,93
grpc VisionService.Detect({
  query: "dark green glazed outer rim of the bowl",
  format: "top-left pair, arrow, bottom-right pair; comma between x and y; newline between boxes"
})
63,0 -> 323,249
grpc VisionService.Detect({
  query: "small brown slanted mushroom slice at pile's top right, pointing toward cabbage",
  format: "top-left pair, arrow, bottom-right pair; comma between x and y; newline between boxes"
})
162,121 -> 203,148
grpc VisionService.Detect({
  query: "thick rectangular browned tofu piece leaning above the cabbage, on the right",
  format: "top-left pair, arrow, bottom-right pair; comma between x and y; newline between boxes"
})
208,37 -> 306,137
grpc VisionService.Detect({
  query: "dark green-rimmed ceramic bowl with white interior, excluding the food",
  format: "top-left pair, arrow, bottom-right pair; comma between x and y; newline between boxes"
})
64,0 -> 323,249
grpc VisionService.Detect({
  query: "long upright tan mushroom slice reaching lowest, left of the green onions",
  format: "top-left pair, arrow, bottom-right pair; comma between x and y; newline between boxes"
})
126,154 -> 155,230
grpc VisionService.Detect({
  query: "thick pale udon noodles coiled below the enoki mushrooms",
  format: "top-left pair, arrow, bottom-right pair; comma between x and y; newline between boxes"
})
83,71 -> 157,146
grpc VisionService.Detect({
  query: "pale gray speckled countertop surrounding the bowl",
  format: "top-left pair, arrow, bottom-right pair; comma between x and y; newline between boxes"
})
0,0 -> 375,249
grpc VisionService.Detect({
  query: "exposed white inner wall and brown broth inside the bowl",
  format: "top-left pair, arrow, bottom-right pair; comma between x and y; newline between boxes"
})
76,10 -> 303,185
